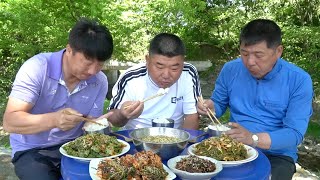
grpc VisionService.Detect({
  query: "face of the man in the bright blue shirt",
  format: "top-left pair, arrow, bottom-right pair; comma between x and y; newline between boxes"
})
240,41 -> 283,79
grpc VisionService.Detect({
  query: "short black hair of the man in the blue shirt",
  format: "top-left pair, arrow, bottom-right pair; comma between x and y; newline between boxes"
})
240,19 -> 281,48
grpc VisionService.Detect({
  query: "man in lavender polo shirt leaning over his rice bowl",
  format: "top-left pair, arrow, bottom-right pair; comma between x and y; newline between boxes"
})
3,19 -> 113,180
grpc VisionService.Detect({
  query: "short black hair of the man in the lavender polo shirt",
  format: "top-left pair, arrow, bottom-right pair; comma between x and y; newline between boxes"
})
68,18 -> 113,61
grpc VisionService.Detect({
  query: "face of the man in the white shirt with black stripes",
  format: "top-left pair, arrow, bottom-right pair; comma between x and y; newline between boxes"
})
146,55 -> 184,88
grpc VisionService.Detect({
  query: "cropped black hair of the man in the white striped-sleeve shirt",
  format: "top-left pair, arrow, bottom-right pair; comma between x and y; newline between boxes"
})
149,33 -> 186,57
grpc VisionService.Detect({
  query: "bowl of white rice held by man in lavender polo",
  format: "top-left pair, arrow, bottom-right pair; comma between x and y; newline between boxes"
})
83,118 -> 110,135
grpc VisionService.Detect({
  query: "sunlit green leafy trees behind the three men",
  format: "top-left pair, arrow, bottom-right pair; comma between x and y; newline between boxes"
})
0,0 -> 320,126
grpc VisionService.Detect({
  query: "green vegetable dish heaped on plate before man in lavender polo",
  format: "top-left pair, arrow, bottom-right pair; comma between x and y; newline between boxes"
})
63,133 -> 126,158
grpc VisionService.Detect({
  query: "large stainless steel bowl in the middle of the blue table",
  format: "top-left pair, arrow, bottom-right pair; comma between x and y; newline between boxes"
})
130,127 -> 190,160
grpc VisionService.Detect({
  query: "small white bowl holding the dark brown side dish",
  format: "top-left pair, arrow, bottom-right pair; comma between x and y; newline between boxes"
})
167,155 -> 223,180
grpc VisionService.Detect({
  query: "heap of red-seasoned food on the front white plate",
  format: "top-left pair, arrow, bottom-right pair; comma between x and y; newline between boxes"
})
97,151 -> 168,180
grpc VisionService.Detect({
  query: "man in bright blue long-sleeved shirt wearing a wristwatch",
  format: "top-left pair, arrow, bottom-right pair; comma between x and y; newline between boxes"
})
198,19 -> 313,180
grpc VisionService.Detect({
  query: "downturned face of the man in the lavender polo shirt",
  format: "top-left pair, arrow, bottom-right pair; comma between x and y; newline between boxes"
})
66,47 -> 104,80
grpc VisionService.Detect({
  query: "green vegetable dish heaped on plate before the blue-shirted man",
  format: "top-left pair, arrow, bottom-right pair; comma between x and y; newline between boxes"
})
193,135 -> 248,161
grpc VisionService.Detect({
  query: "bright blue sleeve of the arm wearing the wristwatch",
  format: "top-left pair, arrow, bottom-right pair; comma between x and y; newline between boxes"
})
269,75 -> 313,150
